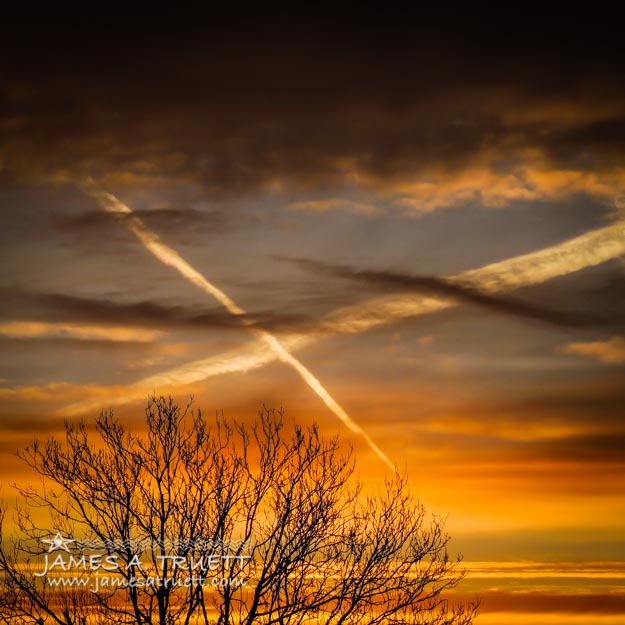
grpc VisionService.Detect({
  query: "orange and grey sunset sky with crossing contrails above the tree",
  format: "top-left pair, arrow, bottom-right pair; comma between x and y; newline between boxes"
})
0,15 -> 625,625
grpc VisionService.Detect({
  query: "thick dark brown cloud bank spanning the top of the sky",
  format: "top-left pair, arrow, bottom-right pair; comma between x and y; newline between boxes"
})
0,16 -> 625,201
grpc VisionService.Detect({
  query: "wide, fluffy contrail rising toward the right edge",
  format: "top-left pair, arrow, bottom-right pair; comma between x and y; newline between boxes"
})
64,197 -> 625,432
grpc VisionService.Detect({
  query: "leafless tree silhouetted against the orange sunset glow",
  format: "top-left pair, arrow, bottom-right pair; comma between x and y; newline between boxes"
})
0,397 -> 477,625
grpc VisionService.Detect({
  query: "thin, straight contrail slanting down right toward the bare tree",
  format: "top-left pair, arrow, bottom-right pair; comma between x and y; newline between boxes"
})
83,183 -> 395,471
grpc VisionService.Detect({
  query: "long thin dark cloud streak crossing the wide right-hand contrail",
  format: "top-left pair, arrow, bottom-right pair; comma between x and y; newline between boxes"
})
285,259 -> 605,327
